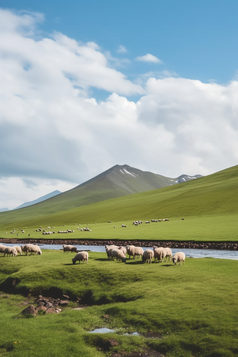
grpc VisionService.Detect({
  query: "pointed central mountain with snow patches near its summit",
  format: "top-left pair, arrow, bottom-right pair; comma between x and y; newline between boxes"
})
0,165 -> 201,219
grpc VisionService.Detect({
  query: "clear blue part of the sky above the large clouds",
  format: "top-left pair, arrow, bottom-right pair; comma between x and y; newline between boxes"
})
0,0 -> 238,83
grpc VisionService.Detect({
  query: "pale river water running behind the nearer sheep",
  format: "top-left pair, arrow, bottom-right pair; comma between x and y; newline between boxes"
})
2,243 -> 238,260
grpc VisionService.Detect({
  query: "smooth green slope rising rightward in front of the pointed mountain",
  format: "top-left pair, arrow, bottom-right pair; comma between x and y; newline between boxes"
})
0,166 -> 238,227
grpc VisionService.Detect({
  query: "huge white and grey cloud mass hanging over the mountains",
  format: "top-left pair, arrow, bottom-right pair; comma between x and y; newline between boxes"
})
0,10 -> 238,208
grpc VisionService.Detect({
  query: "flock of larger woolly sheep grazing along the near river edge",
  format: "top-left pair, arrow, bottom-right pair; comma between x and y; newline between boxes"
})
0,244 -> 185,265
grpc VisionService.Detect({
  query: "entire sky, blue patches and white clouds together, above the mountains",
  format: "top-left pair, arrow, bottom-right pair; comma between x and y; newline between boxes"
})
0,0 -> 238,209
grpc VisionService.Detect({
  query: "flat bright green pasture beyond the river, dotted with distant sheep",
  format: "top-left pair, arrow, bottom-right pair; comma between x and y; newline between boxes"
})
0,214 -> 238,242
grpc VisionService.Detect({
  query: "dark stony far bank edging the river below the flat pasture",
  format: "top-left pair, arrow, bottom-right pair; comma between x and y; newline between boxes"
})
0,238 -> 238,251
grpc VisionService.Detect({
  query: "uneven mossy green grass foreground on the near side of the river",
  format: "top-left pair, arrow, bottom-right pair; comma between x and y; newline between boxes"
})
0,250 -> 238,357
